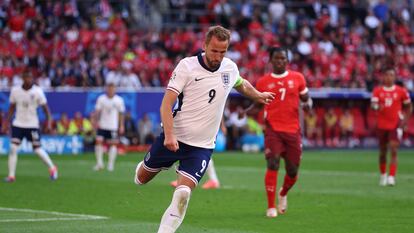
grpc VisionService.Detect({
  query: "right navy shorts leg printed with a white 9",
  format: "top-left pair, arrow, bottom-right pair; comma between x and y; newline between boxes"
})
177,145 -> 213,185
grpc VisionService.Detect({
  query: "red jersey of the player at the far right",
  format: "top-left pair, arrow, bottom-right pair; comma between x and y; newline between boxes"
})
371,85 -> 411,130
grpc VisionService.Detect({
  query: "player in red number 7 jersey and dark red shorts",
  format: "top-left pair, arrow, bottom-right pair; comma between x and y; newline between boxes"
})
247,47 -> 312,217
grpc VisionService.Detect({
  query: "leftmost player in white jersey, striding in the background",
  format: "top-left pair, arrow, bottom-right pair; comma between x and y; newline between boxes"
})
2,71 -> 58,182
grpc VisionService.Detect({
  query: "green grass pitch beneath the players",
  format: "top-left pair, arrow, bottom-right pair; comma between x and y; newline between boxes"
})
0,150 -> 414,233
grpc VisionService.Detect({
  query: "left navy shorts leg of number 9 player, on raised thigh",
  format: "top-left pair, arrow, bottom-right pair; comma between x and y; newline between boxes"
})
143,134 -> 181,172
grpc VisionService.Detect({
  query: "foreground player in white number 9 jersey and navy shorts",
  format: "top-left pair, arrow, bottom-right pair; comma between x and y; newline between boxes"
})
134,26 -> 274,233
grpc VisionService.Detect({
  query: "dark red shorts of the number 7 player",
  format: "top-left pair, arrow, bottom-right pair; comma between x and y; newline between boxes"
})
265,127 -> 302,166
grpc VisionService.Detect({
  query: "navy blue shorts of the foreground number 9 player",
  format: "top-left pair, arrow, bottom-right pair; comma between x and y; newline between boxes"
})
144,134 -> 213,185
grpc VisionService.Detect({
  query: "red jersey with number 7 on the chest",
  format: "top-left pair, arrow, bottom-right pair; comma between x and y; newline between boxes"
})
256,70 -> 308,133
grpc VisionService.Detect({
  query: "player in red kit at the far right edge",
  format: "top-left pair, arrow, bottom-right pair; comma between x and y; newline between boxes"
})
371,68 -> 412,186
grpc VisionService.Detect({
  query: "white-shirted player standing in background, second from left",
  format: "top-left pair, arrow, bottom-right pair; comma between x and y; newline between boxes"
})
94,83 -> 125,171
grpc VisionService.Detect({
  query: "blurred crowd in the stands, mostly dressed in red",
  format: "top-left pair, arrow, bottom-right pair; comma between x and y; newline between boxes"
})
0,0 -> 414,91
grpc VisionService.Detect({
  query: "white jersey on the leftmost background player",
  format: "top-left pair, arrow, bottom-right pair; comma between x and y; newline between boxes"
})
10,85 -> 47,128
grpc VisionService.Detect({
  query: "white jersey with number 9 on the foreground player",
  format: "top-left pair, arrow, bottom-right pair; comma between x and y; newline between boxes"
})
167,54 -> 242,149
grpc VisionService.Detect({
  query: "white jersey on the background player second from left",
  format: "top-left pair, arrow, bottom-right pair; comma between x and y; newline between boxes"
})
95,94 -> 125,131
